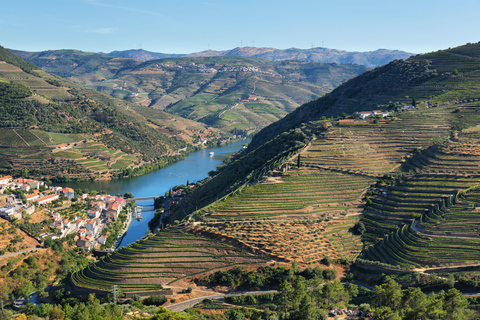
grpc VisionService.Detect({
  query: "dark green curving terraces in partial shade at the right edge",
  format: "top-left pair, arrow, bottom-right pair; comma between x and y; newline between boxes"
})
362,142 -> 480,269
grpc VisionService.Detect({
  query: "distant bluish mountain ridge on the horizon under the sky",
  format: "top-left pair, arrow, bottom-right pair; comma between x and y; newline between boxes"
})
187,47 -> 414,67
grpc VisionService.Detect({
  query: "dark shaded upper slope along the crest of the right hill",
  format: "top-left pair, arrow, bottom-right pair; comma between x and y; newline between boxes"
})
252,44 -> 480,146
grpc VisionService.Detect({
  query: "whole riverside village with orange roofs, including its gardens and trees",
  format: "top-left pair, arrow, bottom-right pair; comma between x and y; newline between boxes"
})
0,176 -> 133,251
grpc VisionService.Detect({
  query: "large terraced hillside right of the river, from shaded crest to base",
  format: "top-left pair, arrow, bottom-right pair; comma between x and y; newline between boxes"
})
167,44 -> 480,269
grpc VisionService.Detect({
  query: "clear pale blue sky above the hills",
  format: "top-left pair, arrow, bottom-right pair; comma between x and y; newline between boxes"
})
0,0 -> 480,53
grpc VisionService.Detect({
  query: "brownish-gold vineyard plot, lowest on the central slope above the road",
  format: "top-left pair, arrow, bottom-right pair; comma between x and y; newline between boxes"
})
192,218 -> 363,264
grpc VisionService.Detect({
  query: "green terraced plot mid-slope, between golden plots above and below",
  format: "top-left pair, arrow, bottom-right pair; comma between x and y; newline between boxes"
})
208,169 -> 374,220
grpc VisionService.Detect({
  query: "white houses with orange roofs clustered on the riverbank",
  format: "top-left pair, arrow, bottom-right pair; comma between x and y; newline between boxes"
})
0,176 -> 127,250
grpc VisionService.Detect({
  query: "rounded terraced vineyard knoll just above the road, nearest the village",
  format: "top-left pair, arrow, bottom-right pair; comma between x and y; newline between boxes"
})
72,232 -> 266,292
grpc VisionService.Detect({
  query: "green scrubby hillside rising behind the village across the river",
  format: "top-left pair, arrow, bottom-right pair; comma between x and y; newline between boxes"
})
0,47 -> 225,179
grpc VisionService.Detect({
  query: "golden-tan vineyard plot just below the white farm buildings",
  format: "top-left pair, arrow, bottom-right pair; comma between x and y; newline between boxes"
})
303,114 -> 450,175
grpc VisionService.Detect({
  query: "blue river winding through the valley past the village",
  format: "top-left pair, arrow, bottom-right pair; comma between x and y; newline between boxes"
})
55,139 -> 250,246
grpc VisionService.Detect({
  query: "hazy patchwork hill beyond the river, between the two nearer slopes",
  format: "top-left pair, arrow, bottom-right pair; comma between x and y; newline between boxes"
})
14,50 -> 367,133
